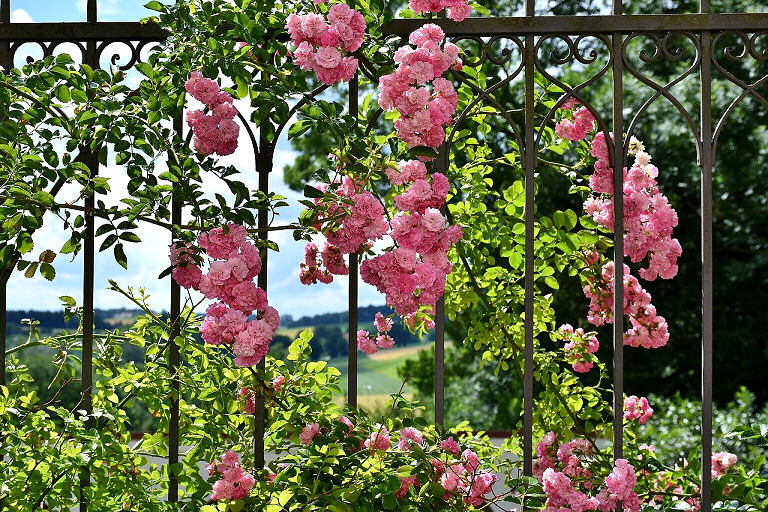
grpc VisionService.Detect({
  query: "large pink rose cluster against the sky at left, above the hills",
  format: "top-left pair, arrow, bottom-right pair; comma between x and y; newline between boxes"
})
171,224 -> 280,366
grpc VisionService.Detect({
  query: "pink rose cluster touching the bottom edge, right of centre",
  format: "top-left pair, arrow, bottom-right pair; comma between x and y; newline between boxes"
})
534,432 -> 640,512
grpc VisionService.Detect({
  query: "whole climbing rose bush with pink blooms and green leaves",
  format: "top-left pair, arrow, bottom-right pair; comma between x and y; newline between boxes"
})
0,0 -> 765,512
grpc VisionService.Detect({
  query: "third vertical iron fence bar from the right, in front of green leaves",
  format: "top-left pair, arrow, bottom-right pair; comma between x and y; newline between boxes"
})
523,0 -> 538,476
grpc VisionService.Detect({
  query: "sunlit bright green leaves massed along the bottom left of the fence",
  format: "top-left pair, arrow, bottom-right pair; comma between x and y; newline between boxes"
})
0,285 -> 515,511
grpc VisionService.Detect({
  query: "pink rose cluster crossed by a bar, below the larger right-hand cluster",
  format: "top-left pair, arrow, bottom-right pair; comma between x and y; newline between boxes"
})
584,261 -> 669,348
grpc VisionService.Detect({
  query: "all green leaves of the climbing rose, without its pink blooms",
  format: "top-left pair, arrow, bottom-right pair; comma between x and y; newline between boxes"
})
0,0 -> 766,512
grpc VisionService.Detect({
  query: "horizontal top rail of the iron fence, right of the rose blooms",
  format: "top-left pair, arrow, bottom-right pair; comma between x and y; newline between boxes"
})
382,13 -> 768,37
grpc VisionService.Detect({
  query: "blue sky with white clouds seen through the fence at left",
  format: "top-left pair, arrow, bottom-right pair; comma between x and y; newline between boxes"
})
8,0 -> 384,316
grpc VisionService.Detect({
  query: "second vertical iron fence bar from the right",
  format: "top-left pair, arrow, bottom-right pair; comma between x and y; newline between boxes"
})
612,0 -> 624,472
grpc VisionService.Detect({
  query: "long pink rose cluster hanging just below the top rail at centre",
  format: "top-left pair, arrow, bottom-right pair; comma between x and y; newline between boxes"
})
378,24 -> 462,149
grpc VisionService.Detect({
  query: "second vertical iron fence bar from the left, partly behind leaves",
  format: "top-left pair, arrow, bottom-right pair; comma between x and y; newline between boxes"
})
80,5 -> 99,512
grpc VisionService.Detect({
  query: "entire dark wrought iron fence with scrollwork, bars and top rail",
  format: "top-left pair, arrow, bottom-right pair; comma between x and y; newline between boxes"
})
0,0 -> 768,512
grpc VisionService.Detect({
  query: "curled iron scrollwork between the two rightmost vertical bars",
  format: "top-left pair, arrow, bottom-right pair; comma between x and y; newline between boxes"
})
621,32 -> 701,159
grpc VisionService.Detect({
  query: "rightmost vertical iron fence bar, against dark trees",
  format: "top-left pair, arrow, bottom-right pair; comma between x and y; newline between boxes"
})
699,0 -> 713,512
